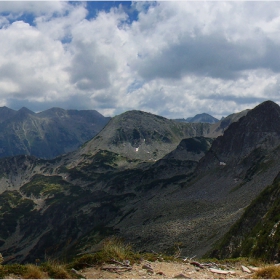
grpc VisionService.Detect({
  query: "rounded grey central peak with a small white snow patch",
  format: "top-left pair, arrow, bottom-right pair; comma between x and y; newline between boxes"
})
78,110 -> 210,161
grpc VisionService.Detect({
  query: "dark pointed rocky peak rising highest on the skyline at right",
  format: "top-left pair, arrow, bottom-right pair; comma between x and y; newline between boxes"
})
198,101 -> 280,167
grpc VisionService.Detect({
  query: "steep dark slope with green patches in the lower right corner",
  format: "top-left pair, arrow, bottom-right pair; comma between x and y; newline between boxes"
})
208,171 -> 280,262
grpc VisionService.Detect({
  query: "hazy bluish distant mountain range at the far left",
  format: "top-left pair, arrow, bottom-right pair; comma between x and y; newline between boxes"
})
0,107 -> 110,158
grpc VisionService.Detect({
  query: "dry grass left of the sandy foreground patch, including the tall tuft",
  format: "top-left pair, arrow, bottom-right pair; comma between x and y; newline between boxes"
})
0,237 -> 167,279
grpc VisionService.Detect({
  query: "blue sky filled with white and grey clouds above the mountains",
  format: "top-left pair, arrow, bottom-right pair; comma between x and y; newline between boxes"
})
0,1 -> 280,118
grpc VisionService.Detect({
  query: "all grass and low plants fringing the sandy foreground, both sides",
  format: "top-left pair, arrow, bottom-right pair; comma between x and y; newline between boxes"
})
0,237 -> 280,279
